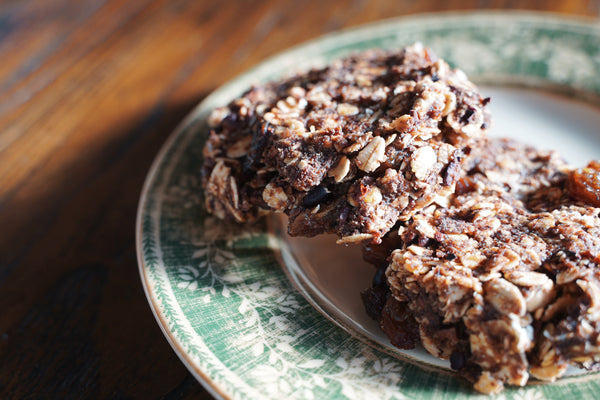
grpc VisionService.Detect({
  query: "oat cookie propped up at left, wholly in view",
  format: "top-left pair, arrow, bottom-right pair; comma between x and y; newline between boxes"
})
203,44 -> 489,243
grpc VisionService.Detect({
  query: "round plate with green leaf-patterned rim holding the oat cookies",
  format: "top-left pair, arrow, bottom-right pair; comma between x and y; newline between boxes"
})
136,13 -> 600,400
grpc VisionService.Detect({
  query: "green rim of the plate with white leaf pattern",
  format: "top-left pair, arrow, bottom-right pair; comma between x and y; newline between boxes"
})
138,14 -> 600,400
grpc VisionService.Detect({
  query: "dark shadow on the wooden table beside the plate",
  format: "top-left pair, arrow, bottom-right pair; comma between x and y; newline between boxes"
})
0,94 -> 216,399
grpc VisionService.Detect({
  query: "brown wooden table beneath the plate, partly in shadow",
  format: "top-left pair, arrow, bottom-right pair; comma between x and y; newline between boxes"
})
0,0 -> 600,399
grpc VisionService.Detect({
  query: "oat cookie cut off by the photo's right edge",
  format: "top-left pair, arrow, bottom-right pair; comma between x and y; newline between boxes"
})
363,140 -> 600,393
